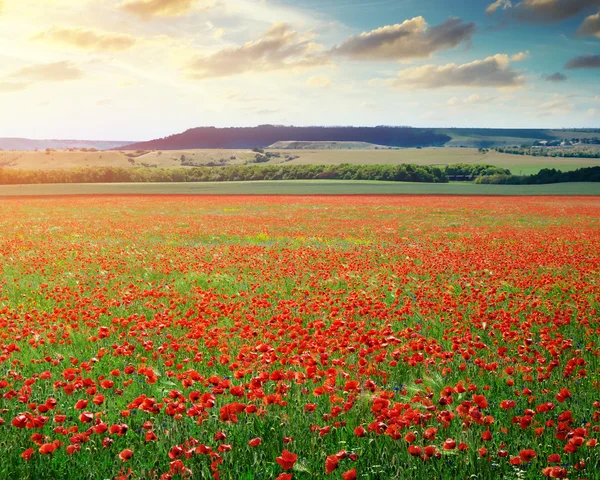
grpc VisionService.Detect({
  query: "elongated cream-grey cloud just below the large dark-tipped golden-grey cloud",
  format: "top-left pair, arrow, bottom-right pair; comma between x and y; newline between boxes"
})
385,54 -> 525,89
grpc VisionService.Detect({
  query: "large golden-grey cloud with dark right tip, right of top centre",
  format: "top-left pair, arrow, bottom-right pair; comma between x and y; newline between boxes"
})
331,17 -> 475,60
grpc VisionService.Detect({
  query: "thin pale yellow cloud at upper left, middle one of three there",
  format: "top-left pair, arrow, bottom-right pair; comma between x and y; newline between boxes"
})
35,27 -> 136,52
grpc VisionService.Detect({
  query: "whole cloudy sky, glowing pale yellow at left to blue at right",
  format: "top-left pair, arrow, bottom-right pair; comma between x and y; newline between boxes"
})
0,0 -> 600,140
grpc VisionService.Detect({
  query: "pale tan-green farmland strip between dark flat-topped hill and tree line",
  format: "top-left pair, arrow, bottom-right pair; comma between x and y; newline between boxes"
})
0,148 -> 600,175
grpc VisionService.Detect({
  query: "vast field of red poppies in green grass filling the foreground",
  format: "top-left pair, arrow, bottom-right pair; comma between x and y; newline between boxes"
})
0,195 -> 600,480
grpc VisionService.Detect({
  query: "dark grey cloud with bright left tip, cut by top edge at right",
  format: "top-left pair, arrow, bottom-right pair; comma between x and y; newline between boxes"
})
487,0 -> 600,23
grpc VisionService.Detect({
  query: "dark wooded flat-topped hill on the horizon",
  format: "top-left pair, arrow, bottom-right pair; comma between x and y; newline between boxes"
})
118,125 -> 451,150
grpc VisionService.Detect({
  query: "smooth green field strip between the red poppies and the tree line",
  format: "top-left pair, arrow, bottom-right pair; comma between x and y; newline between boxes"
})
0,180 -> 600,196
